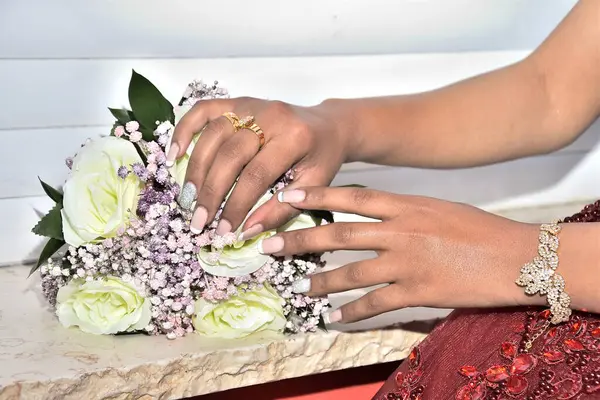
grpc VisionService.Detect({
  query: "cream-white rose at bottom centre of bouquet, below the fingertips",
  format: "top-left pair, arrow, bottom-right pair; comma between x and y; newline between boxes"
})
192,284 -> 286,339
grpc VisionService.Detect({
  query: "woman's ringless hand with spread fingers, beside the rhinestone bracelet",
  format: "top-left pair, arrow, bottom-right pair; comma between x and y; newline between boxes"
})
262,187 -> 544,322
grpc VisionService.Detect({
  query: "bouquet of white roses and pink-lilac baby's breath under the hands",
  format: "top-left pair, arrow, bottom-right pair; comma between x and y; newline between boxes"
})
31,71 -> 331,339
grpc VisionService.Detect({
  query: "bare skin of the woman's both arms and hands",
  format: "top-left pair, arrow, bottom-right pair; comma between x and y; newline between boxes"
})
167,0 -> 600,322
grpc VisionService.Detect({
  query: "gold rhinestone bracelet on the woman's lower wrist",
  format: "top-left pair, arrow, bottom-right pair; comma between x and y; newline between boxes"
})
516,222 -> 572,324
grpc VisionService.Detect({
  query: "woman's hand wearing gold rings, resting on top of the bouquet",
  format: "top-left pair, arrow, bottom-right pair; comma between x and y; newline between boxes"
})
167,98 -> 352,239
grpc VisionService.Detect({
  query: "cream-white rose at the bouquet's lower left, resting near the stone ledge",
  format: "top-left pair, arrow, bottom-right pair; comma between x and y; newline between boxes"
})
56,277 -> 151,335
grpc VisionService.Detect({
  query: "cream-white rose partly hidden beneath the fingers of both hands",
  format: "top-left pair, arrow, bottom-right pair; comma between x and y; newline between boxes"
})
198,192 -> 317,277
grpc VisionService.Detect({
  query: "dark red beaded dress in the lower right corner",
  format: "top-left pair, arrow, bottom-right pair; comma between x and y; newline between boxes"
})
375,200 -> 600,400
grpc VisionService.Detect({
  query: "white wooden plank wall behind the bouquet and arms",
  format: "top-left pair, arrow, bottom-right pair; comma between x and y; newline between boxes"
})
0,0 -> 600,264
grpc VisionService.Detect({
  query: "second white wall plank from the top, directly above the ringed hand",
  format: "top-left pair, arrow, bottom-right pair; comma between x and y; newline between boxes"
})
0,51 -> 528,130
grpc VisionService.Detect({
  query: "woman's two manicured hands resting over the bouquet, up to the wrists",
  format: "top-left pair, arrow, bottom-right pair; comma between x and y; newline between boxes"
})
168,99 -> 537,322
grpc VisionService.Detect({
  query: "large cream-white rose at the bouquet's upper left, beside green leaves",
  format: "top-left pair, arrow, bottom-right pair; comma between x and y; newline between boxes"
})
61,136 -> 143,247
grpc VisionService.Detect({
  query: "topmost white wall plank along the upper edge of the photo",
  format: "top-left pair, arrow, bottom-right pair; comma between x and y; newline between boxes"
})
0,0 -> 575,59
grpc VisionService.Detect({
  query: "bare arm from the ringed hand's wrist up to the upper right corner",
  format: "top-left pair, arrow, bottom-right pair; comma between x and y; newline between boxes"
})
322,0 -> 600,168
